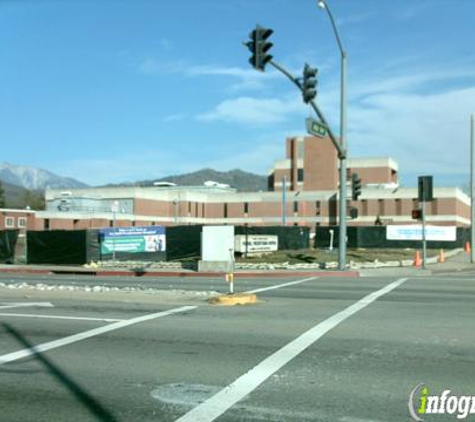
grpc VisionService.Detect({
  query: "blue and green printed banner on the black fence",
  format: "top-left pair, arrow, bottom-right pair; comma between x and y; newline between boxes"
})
99,226 -> 166,254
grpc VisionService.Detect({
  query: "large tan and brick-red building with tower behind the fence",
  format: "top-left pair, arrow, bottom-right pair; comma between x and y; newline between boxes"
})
3,136 -> 470,231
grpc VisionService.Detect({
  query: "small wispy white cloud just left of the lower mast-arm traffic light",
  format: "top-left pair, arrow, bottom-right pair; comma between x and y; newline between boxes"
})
197,97 -> 306,125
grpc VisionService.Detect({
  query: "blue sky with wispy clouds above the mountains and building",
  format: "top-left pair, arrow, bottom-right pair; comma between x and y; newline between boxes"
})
0,0 -> 475,186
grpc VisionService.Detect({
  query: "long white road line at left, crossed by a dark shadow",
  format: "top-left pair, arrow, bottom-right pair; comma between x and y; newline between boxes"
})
0,306 -> 198,366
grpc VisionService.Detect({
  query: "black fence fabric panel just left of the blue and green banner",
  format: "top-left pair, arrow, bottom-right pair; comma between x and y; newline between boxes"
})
27,230 -> 87,265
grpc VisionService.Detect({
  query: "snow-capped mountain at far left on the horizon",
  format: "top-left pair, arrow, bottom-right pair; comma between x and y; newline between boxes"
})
0,163 -> 88,190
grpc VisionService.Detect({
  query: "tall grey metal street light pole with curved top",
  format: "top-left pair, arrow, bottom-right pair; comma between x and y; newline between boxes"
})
318,0 -> 348,270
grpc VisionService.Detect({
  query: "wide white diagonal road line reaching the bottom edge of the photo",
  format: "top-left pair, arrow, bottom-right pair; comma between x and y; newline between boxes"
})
176,278 -> 407,422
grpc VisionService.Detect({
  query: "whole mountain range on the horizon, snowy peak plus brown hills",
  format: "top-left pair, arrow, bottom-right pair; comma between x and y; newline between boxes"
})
0,163 -> 267,209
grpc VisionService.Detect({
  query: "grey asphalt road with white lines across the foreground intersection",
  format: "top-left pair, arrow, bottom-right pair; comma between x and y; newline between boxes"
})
0,273 -> 475,422
